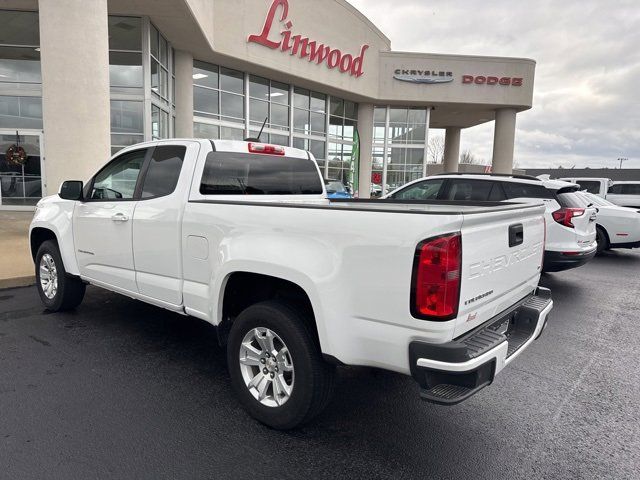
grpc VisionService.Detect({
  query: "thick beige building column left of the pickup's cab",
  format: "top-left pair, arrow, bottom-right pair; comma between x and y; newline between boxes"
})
38,0 -> 111,195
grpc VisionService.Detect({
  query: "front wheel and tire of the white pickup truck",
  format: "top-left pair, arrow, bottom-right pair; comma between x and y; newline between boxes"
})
35,240 -> 86,312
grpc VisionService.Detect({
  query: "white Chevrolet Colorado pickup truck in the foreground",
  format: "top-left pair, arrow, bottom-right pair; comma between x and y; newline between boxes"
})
30,140 -> 553,429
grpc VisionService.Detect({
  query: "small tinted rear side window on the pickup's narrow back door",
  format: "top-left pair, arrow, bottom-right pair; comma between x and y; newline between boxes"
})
141,145 -> 187,199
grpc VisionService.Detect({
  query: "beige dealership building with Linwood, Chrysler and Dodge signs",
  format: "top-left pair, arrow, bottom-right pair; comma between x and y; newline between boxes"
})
0,0 -> 535,209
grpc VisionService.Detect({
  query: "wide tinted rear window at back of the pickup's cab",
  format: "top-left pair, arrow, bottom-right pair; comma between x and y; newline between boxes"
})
200,152 -> 322,195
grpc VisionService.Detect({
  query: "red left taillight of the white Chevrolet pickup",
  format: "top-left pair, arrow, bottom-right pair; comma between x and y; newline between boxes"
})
411,233 -> 462,320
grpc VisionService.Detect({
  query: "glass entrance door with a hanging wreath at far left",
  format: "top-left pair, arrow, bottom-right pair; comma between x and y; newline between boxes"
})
0,130 -> 43,208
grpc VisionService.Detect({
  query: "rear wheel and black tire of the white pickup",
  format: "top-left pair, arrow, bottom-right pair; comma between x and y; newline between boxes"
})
227,301 -> 335,430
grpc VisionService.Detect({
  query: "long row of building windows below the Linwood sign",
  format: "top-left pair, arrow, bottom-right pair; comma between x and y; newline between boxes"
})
193,60 -> 358,191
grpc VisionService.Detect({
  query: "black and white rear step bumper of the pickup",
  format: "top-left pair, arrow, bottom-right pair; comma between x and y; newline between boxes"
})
409,287 -> 553,405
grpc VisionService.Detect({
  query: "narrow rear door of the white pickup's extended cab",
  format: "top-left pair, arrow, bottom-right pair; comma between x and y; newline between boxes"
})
133,142 -> 199,305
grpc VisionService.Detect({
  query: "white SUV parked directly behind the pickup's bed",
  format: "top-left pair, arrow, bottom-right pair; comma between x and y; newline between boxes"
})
384,174 -> 597,272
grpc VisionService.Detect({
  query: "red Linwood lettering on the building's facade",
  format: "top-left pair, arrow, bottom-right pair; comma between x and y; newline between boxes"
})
247,0 -> 369,78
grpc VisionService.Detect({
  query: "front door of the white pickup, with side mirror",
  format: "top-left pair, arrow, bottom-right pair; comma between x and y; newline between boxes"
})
73,148 -> 149,292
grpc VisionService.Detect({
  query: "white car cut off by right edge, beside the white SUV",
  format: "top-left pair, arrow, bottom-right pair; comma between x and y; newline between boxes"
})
579,192 -> 640,253
